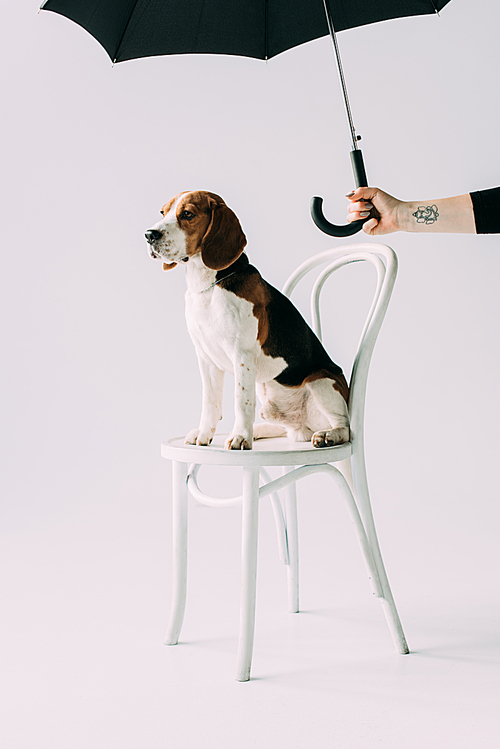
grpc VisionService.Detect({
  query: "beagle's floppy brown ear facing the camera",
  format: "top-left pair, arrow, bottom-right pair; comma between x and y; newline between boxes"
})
201,198 -> 247,270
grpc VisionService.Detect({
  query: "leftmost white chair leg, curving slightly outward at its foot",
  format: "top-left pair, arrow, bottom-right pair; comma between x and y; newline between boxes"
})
165,461 -> 188,645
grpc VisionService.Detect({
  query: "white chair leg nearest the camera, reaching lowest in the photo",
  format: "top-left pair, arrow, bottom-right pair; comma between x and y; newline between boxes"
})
236,466 -> 259,681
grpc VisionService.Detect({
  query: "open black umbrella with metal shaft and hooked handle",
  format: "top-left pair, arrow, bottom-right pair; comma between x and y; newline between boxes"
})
41,0 -> 450,237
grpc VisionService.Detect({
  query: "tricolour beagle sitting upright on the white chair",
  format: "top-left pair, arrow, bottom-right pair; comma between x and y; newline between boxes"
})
145,191 -> 349,450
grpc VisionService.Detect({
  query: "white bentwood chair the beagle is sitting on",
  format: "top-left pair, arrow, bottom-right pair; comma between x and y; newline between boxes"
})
162,243 -> 409,681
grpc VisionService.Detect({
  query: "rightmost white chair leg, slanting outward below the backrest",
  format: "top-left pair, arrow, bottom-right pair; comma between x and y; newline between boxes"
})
352,455 -> 410,655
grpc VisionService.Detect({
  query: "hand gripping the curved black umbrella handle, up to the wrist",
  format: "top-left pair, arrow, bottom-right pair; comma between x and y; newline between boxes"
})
346,187 -> 404,237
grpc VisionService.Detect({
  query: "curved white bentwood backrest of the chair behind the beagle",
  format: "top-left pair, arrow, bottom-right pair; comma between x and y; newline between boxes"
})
283,243 -> 398,449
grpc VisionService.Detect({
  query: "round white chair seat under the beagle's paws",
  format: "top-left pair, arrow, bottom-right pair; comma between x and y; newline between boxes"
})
161,434 -> 352,466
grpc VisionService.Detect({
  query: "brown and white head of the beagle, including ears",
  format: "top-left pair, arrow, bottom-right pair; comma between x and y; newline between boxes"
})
145,190 -> 247,270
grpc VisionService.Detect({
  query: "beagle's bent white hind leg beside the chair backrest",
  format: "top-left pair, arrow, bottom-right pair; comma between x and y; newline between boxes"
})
306,377 -> 349,447
